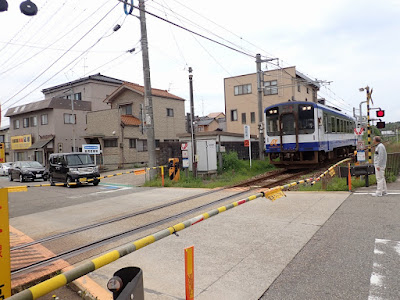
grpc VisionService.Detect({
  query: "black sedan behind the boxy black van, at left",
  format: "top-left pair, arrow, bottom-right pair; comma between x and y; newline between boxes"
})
8,161 -> 49,182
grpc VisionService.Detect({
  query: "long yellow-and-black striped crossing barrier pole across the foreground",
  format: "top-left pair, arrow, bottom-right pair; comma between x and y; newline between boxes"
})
8,158 -> 351,300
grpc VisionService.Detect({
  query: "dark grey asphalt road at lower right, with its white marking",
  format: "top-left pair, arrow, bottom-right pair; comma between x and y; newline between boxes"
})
260,194 -> 400,300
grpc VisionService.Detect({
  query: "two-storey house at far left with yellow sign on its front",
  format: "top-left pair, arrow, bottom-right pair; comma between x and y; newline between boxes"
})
5,98 -> 92,164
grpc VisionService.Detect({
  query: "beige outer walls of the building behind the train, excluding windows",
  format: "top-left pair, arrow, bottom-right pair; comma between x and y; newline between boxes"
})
224,67 -> 316,135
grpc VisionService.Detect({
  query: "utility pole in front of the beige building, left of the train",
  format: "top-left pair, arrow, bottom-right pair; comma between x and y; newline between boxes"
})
256,54 -> 277,160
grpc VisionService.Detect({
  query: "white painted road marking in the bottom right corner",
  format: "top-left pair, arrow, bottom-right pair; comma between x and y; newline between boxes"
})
368,239 -> 400,300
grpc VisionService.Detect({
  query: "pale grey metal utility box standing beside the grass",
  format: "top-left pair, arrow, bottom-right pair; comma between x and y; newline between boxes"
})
188,140 -> 217,173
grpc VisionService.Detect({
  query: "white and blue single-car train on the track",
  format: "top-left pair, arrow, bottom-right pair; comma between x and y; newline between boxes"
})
264,101 -> 357,168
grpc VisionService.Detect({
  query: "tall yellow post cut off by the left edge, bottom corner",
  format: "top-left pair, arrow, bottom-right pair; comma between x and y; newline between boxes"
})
0,189 -> 11,299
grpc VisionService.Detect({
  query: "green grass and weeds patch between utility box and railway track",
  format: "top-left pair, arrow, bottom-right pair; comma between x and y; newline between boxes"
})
143,152 -> 275,188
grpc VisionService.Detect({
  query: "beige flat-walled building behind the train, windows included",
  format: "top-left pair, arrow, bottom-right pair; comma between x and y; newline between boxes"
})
224,67 -> 320,135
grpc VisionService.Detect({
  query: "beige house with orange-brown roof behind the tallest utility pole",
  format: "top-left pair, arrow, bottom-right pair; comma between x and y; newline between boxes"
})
84,82 -> 185,167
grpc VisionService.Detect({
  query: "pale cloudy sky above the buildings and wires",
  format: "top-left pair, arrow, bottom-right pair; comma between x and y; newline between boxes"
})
0,0 -> 400,125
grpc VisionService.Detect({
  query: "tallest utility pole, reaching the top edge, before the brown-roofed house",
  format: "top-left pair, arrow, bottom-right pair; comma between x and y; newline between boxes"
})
139,0 -> 156,180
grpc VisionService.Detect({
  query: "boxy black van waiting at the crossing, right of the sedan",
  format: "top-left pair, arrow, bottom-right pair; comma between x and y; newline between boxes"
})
49,152 -> 100,187
